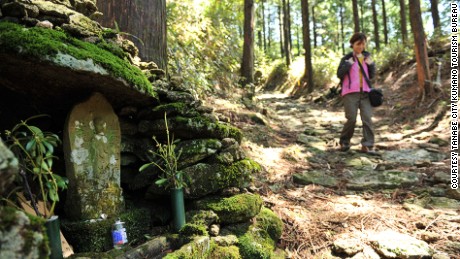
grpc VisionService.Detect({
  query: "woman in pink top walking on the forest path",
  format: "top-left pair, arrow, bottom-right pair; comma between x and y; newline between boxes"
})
337,32 -> 375,153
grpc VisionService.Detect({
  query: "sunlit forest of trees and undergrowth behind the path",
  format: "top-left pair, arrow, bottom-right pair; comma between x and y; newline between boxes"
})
98,0 -> 450,102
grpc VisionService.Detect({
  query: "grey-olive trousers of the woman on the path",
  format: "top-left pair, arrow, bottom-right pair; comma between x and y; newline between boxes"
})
340,93 -> 374,147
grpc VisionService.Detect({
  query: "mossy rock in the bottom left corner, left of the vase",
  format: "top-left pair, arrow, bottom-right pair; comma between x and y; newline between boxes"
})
0,207 -> 50,258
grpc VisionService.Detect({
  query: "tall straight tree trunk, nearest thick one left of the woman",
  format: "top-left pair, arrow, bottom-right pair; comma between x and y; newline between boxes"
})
300,0 -> 313,94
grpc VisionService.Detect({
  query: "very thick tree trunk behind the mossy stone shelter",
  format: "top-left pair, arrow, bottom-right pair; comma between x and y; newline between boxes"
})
97,0 -> 168,72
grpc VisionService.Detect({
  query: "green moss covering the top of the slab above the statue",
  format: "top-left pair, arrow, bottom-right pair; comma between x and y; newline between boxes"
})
0,22 -> 156,96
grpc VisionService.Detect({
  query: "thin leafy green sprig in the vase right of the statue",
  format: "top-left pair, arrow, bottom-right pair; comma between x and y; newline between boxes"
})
139,113 -> 187,189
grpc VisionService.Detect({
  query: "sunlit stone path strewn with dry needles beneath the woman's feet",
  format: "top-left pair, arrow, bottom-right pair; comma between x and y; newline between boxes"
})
218,94 -> 460,258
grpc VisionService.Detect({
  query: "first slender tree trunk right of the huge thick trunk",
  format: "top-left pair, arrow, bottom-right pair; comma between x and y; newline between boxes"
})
241,0 -> 255,86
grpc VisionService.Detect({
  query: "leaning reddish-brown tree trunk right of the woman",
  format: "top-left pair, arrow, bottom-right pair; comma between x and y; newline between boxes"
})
409,0 -> 433,102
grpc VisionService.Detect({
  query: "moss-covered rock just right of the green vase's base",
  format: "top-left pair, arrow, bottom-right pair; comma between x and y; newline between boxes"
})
193,193 -> 263,224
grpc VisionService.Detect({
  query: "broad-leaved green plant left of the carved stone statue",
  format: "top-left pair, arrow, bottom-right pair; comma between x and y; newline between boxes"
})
6,115 -> 68,218
